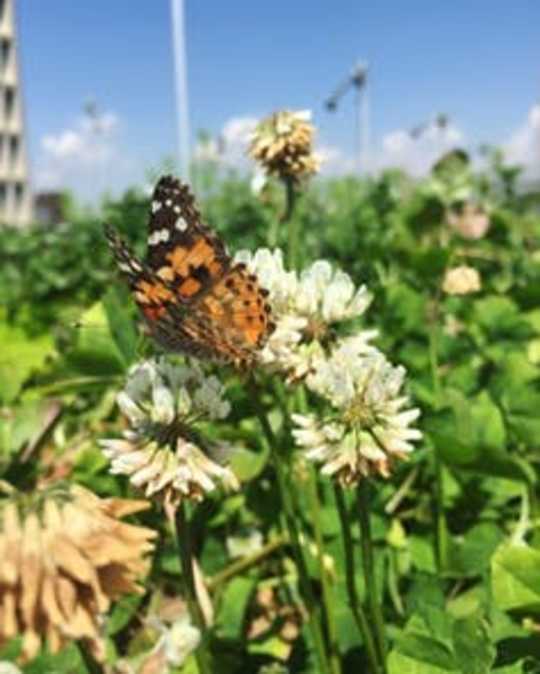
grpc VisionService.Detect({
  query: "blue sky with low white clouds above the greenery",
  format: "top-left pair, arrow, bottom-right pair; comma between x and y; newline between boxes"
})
18,0 -> 540,196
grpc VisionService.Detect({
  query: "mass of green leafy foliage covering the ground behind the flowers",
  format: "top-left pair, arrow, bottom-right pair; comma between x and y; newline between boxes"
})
0,153 -> 540,674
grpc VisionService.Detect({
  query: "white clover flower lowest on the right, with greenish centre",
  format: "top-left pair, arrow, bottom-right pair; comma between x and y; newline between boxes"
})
293,346 -> 422,485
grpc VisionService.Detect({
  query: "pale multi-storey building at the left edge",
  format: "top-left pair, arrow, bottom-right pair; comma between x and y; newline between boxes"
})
0,0 -> 33,226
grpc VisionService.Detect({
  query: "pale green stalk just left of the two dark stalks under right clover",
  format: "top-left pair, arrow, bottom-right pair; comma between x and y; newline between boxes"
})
309,469 -> 341,674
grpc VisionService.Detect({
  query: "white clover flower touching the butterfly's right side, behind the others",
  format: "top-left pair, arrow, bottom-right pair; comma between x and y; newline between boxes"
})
236,248 -> 377,380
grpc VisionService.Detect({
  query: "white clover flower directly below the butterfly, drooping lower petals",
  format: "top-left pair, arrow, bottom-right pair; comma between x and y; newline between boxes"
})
100,359 -> 238,501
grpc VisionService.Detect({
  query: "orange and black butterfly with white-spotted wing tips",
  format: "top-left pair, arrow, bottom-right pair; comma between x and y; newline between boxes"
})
105,175 -> 275,368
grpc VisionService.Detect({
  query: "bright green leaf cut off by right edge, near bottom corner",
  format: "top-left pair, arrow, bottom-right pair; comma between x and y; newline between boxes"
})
491,543 -> 540,611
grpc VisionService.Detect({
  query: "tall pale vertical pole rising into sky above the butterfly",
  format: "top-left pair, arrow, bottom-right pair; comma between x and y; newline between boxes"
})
171,0 -> 190,181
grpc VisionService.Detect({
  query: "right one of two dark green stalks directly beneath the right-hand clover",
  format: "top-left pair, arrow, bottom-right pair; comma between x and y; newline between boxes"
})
357,479 -> 386,672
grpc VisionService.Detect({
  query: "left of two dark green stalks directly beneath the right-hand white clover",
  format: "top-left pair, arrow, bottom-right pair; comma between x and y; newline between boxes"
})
334,486 -> 381,674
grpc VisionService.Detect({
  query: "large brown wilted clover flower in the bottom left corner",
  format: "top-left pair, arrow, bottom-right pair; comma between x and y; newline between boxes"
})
0,485 -> 156,660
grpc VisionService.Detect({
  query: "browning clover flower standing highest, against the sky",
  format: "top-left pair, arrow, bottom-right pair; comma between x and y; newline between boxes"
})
248,110 -> 320,182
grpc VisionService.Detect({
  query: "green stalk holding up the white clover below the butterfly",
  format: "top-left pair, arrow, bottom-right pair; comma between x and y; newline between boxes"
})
174,502 -> 213,674
